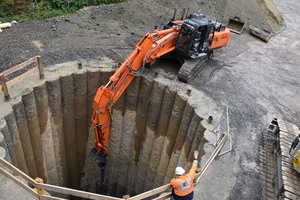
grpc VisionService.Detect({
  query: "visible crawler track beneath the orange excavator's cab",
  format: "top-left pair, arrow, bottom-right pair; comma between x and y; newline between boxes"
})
177,54 -> 209,83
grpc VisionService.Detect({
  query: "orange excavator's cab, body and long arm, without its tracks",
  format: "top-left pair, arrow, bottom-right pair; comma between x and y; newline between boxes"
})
91,10 -> 230,164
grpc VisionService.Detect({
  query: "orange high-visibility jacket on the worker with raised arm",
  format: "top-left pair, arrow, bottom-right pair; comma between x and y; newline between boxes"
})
171,160 -> 198,196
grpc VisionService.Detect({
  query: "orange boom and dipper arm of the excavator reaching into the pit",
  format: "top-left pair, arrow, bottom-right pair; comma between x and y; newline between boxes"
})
91,26 -> 180,163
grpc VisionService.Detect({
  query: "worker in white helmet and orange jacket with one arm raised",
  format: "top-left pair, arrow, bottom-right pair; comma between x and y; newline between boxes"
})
171,151 -> 199,200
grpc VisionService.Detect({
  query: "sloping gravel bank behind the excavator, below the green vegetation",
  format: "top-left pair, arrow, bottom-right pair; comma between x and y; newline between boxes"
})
0,0 -> 283,72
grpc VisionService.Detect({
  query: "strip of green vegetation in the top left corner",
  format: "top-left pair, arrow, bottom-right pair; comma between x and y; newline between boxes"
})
0,0 -> 127,22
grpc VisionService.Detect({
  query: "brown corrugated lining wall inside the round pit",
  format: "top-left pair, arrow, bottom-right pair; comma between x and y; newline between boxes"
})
0,61 -> 216,196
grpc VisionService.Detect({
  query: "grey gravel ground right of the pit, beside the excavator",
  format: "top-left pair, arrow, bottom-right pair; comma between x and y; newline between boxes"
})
192,0 -> 300,199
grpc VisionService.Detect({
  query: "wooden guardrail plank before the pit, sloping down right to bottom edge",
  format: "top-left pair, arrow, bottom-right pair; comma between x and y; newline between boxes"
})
36,183 -> 122,200
